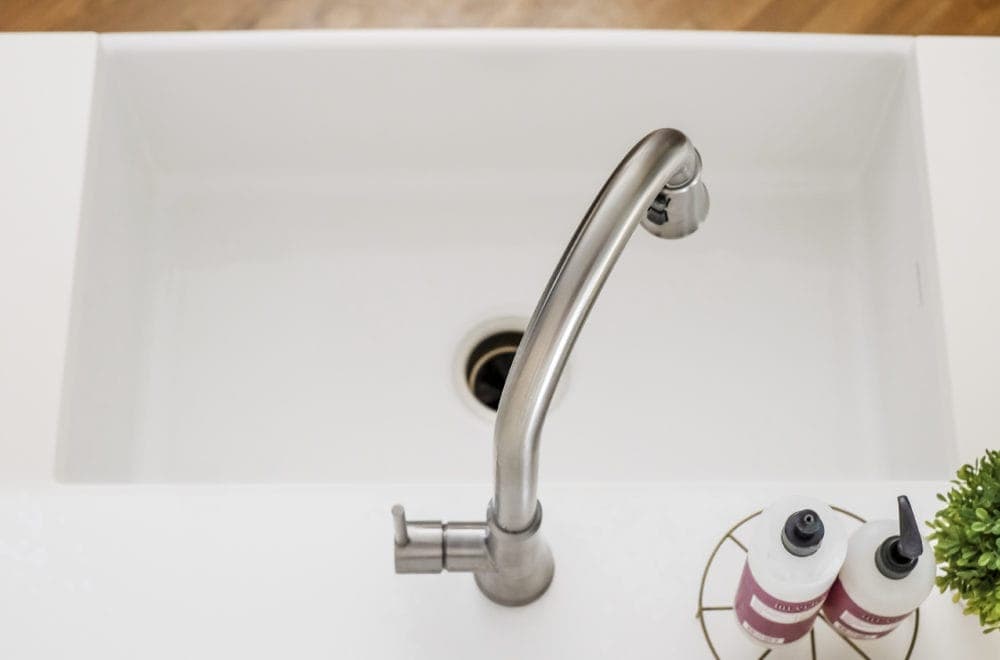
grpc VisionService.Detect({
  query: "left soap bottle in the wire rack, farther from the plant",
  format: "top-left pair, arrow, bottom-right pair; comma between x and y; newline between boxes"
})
734,497 -> 847,647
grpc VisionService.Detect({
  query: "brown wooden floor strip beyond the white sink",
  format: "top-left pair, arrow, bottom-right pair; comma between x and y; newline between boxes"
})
0,0 -> 1000,35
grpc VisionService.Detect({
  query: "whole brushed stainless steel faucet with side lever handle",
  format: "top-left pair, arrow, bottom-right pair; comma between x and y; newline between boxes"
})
392,128 -> 708,605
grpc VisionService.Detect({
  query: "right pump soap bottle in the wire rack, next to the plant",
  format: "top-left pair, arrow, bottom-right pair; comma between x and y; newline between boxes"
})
823,495 -> 936,639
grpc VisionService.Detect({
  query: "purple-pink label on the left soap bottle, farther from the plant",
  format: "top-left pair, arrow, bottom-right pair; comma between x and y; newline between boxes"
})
735,562 -> 826,645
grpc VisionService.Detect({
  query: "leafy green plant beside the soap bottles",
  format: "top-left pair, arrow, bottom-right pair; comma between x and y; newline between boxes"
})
927,450 -> 1000,633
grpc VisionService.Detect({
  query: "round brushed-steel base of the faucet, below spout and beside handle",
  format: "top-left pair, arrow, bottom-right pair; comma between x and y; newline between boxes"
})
475,503 -> 555,607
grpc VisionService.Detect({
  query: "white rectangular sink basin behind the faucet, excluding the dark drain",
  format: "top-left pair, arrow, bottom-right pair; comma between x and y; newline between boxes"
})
57,33 -> 955,483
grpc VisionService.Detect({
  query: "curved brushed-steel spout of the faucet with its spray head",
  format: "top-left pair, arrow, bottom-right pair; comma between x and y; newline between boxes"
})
493,129 -> 708,532
